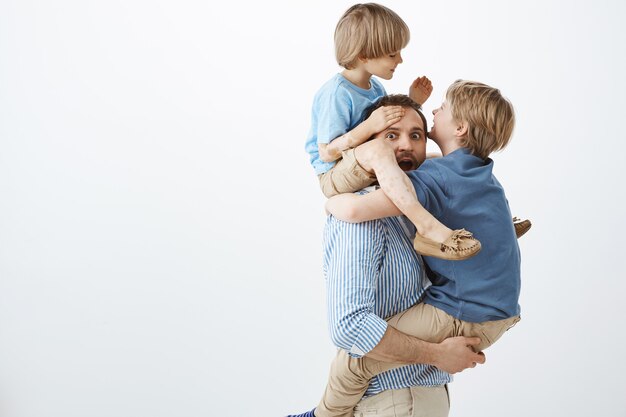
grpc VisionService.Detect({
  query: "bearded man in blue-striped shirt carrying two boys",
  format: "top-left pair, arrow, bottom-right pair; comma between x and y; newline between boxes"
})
288,95 -> 485,417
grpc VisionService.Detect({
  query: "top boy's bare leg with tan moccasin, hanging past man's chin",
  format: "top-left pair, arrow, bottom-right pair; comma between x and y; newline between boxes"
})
355,139 -> 480,260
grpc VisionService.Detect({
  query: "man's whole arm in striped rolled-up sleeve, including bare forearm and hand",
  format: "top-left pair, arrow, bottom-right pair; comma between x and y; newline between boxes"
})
324,217 -> 485,373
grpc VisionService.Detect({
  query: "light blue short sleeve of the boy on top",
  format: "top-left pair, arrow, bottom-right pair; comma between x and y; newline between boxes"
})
316,87 -> 352,143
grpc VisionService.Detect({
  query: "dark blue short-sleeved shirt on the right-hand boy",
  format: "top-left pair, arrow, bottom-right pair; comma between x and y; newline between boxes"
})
408,148 -> 520,323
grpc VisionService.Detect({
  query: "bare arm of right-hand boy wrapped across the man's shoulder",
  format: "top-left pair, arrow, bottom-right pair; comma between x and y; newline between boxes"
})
326,189 -> 402,223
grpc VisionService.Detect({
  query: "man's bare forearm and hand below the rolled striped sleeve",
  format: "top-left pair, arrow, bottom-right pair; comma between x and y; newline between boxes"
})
366,326 -> 485,374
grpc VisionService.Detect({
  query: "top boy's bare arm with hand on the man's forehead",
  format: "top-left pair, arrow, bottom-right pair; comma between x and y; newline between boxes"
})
318,106 -> 405,162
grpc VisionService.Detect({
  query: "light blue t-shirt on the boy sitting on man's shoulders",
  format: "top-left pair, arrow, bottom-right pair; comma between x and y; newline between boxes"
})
305,74 -> 387,175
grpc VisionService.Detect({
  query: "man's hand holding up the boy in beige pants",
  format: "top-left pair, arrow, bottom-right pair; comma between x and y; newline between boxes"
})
431,336 -> 485,374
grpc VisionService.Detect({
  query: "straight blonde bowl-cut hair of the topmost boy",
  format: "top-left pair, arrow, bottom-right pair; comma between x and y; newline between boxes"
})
335,3 -> 410,69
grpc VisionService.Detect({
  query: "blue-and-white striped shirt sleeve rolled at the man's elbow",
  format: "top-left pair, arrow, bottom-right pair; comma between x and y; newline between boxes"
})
324,216 -> 387,357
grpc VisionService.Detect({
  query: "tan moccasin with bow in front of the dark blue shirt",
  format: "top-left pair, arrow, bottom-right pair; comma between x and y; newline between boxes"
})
413,229 -> 480,261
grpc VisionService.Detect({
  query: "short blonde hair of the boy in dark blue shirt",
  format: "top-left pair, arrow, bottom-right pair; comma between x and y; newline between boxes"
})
446,80 -> 515,159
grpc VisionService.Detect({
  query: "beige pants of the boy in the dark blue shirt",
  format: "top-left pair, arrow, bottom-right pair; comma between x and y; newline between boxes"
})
315,303 -> 519,417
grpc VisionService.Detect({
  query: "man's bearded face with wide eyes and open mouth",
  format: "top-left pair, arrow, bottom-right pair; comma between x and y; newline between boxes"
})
375,108 -> 426,171
